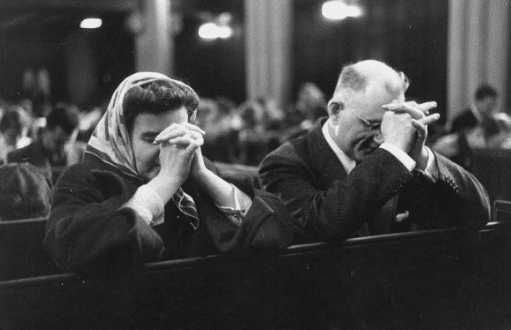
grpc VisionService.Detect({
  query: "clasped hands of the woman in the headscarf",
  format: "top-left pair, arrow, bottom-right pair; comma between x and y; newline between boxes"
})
154,123 -> 204,185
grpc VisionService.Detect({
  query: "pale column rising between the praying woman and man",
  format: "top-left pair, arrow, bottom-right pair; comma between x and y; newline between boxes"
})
245,0 -> 292,107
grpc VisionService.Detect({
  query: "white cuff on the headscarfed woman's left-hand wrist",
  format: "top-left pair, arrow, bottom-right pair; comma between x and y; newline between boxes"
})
122,185 -> 165,226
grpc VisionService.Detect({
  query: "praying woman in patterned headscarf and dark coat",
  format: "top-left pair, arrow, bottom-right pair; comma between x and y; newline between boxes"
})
44,72 -> 292,271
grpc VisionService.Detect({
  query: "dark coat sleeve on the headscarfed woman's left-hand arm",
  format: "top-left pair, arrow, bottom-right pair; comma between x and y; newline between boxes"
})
43,164 -> 163,272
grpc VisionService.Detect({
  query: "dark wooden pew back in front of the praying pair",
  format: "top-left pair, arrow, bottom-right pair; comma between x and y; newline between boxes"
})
0,218 -> 511,329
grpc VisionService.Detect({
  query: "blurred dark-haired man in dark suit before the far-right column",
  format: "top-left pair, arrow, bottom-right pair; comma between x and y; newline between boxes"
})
451,85 -> 498,135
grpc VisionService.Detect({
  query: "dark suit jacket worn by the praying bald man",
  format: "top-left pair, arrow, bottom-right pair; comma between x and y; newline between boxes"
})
259,119 -> 490,241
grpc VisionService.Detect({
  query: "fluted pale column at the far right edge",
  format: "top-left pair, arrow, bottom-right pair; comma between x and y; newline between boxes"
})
447,0 -> 511,120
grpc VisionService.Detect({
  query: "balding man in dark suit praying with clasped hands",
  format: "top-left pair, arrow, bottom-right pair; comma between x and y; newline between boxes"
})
259,60 -> 490,241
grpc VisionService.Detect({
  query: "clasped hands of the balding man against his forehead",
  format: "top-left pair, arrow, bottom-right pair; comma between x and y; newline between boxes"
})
382,101 -> 440,170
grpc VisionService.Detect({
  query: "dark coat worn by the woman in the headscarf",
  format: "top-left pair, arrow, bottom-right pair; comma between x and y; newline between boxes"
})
44,155 -> 293,271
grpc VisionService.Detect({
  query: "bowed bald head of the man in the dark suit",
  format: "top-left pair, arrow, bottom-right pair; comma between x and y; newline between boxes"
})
328,60 -> 408,160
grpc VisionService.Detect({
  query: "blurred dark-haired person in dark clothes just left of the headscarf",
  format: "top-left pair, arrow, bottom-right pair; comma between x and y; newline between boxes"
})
7,108 -> 79,178
